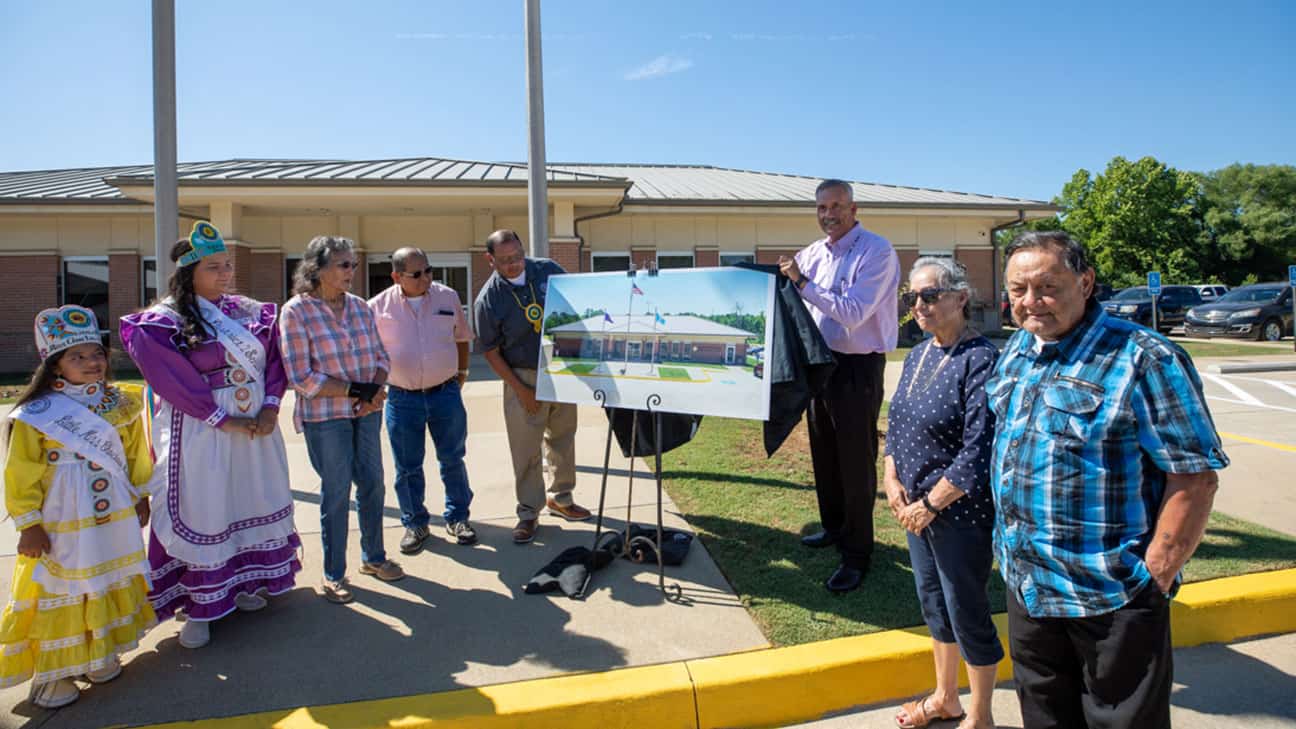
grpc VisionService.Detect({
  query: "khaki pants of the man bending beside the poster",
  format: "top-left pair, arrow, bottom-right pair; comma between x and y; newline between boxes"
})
502,370 -> 575,519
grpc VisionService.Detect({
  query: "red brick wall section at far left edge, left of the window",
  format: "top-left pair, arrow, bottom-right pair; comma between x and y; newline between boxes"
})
0,254 -> 58,374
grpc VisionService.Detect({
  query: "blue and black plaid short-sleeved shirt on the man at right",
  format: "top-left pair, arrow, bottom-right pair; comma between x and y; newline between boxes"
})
986,306 -> 1229,617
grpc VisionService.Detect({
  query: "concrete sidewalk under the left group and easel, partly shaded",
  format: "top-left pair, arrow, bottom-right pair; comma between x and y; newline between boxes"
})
0,370 -> 767,729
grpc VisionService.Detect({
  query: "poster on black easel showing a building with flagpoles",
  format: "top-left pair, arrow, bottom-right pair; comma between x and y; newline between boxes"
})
537,267 -> 774,420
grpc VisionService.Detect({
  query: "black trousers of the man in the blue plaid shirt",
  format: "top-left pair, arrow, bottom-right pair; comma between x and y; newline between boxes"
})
1008,584 -> 1174,729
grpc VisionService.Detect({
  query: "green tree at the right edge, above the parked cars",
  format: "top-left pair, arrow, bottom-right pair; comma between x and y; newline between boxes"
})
1200,165 -> 1296,285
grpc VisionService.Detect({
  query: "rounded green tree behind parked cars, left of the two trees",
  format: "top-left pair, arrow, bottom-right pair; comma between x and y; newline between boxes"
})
1054,157 -> 1204,287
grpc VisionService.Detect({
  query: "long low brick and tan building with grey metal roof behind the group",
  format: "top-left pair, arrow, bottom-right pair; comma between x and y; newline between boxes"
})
0,158 -> 1055,372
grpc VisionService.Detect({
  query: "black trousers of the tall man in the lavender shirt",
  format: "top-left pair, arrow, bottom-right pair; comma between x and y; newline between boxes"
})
806,352 -> 886,568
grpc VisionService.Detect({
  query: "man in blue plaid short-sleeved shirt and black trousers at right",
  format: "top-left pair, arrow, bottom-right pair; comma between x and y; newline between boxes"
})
986,232 -> 1229,729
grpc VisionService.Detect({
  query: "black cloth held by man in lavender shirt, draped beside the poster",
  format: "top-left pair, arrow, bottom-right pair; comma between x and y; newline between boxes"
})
736,263 -> 837,455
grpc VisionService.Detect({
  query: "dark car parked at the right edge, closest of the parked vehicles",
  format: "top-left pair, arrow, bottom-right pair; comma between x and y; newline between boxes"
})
1183,284 -> 1292,341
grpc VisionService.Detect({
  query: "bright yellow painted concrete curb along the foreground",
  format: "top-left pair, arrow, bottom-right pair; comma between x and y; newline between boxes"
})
139,569 -> 1296,729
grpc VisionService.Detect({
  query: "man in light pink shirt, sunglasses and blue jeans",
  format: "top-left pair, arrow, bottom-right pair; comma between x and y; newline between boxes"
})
369,248 -> 477,554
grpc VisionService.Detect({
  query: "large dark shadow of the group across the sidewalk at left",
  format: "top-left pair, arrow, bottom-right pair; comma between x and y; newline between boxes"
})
13,524 -> 635,729
